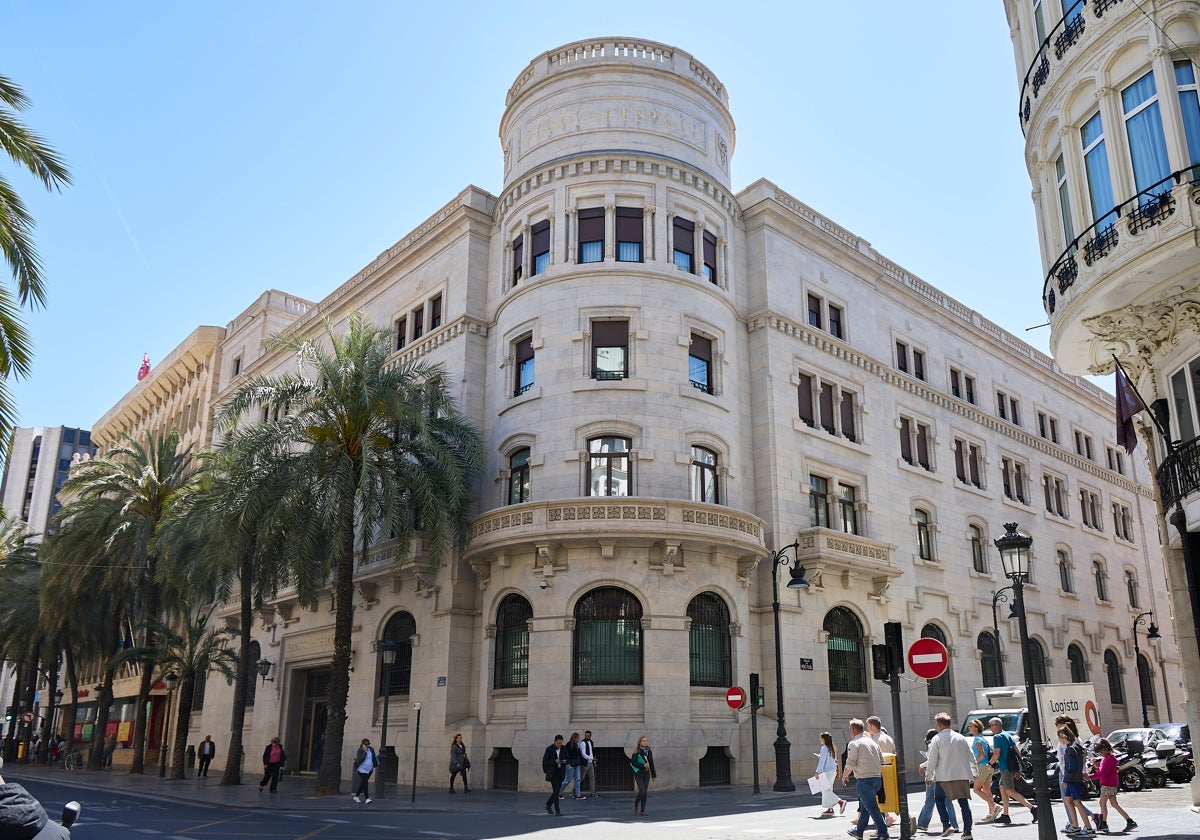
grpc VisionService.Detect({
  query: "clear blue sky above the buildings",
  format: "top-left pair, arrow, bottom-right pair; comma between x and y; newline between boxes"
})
0,0 -> 1049,427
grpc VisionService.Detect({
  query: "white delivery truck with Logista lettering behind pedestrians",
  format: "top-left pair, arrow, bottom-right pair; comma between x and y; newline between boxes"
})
962,683 -> 1103,749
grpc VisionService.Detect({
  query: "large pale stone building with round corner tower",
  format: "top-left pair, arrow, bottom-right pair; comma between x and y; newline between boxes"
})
91,38 -> 1178,790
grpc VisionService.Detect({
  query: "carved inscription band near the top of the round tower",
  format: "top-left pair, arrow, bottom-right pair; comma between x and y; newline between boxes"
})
520,100 -> 708,154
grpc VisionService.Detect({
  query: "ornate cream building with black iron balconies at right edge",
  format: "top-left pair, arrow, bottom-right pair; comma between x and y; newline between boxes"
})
1004,0 -> 1200,787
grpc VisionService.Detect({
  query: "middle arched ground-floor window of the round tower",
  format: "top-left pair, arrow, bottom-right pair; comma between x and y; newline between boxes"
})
575,587 -> 642,685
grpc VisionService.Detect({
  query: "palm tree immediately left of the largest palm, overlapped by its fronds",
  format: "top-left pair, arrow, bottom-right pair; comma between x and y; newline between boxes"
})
160,446 -> 295,785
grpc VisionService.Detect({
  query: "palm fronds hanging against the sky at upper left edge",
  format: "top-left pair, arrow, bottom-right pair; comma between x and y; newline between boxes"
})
0,76 -> 71,440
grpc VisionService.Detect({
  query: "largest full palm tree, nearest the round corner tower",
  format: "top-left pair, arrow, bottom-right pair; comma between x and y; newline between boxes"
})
218,313 -> 482,793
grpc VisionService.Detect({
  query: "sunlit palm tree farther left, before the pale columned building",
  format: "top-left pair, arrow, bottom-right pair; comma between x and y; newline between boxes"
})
54,430 -> 198,773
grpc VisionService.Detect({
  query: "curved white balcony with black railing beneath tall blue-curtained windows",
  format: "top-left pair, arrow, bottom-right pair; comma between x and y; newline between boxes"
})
1042,164 -> 1200,373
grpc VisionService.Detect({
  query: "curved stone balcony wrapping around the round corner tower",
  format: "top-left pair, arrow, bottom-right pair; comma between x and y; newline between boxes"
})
463,496 -> 770,586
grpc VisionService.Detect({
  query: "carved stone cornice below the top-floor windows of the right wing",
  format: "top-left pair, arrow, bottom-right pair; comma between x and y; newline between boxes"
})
746,312 -> 1154,498
